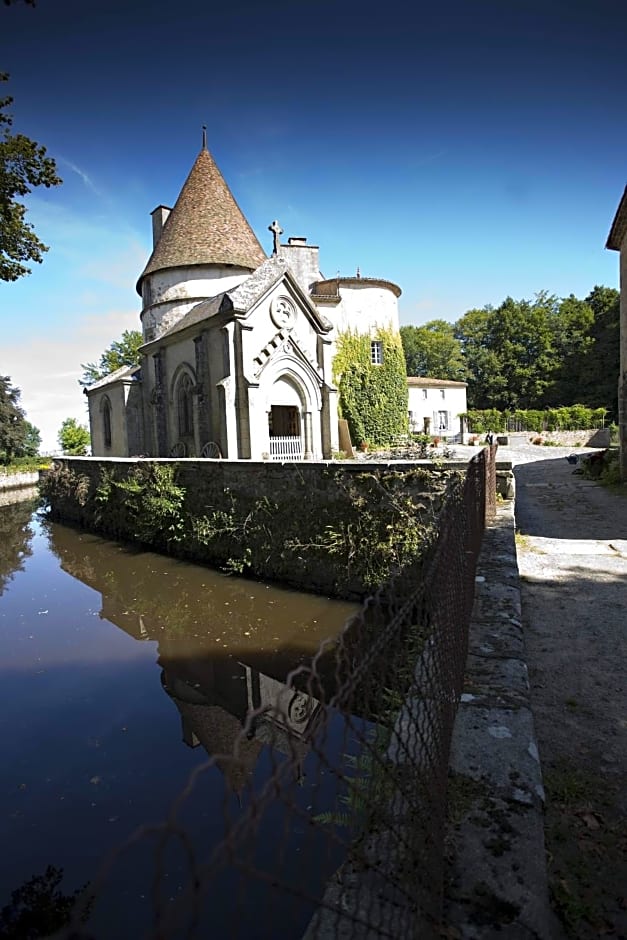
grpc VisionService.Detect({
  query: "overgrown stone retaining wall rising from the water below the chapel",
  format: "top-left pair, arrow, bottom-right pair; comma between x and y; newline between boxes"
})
43,458 -> 458,599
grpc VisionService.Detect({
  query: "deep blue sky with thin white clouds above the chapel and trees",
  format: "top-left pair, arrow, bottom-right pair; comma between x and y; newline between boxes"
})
0,0 -> 627,449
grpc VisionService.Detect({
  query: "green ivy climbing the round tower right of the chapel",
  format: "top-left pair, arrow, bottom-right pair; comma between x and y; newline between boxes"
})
333,327 -> 407,446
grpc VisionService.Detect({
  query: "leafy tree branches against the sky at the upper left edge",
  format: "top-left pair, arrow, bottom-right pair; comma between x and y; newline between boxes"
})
0,73 -> 62,281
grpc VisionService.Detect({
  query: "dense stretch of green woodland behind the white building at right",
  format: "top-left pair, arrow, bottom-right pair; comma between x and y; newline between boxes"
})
401,286 -> 620,421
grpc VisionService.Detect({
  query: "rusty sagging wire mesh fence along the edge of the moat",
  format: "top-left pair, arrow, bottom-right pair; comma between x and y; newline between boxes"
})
56,447 -> 496,940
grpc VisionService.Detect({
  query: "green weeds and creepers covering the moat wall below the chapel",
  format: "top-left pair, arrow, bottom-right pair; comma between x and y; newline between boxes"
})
44,461 -> 446,597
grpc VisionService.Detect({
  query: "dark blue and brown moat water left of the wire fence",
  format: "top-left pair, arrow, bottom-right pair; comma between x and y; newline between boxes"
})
0,501 -> 355,940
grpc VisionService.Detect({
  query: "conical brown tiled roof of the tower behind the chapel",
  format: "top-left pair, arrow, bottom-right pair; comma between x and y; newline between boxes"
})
137,147 -> 266,293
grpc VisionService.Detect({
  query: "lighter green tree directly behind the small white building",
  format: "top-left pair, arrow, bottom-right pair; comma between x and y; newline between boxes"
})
401,320 -> 466,382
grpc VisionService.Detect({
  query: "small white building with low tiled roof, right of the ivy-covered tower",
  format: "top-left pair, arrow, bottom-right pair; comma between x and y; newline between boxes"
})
407,376 -> 467,440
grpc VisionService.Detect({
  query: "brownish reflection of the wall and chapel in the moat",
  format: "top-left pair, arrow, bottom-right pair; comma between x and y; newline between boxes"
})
49,525 -> 356,794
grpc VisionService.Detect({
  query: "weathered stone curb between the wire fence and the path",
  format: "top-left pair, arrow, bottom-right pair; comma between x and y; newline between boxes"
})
445,501 -> 561,940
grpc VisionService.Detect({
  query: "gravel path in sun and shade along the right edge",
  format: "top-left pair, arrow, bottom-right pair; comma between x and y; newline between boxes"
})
512,445 -> 627,940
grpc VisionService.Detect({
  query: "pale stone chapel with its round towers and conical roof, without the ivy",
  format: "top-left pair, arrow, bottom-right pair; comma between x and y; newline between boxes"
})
86,144 -> 400,460
